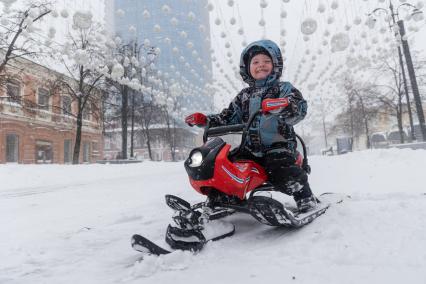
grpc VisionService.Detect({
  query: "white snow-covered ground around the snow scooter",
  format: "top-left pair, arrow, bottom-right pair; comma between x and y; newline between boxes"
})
0,149 -> 426,284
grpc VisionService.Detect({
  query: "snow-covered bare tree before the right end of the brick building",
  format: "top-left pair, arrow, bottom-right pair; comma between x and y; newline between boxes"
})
58,12 -> 105,164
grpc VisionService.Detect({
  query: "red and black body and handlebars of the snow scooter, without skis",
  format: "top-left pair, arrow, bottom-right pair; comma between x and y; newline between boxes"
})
185,98 -> 310,203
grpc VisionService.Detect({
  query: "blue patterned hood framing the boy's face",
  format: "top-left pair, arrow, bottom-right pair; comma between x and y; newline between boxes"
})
240,39 -> 283,87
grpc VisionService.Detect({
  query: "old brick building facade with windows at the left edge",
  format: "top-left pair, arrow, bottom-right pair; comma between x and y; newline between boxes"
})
0,59 -> 103,164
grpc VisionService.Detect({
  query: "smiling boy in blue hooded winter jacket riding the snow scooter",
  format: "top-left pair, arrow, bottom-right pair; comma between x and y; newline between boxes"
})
185,40 -> 316,212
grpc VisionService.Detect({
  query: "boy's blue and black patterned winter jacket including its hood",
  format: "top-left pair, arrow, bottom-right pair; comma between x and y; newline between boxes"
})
208,40 -> 307,157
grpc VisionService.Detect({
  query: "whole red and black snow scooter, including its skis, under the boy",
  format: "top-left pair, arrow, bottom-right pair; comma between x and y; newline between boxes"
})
132,98 -> 329,254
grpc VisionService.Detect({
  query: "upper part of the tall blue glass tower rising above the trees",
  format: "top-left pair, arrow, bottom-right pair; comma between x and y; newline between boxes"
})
112,0 -> 213,110
